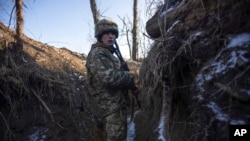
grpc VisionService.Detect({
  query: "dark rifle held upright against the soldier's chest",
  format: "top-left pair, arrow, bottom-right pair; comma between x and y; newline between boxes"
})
114,41 -> 141,108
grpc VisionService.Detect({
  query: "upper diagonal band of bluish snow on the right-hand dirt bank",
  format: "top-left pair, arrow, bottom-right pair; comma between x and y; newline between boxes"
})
196,33 -> 250,93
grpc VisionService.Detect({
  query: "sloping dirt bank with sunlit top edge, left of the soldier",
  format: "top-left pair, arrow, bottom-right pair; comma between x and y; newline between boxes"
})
0,23 -> 103,141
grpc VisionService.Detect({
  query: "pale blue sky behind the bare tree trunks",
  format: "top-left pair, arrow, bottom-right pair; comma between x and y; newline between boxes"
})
0,0 -> 150,58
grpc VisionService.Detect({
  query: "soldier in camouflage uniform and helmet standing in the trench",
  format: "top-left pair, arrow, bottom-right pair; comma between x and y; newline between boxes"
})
86,19 -> 138,141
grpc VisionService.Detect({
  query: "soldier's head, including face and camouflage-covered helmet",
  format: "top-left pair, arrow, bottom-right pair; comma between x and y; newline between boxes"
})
95,19 -> 119,45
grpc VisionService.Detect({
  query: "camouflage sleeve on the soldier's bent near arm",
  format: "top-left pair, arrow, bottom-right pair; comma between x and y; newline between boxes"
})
89,54 -> 134,88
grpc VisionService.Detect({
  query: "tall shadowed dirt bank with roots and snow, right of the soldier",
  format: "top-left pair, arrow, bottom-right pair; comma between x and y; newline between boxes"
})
136,0 -> 250,141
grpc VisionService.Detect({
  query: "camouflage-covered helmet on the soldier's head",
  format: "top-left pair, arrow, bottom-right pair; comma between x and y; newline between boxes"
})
95,19 -> 119,38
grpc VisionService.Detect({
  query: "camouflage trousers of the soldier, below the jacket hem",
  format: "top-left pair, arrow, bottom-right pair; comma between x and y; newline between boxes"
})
105,110 -> 127,141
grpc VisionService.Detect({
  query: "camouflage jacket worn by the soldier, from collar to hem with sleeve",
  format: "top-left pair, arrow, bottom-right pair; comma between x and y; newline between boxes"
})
86,43 -> 134,113
